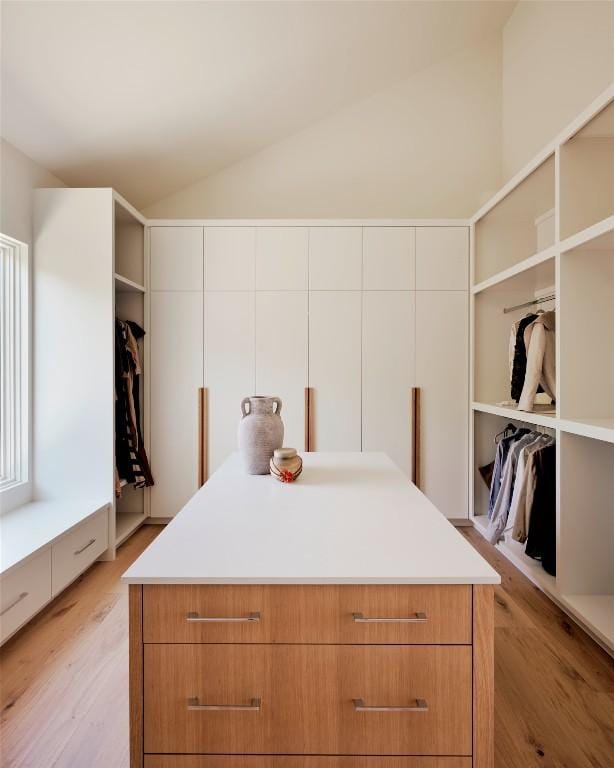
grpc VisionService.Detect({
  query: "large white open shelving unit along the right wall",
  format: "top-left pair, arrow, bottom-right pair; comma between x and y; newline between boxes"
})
470,86 -> 614,655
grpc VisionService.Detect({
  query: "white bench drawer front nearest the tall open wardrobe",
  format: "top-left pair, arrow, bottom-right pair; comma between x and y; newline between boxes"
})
51,507 -> 108,597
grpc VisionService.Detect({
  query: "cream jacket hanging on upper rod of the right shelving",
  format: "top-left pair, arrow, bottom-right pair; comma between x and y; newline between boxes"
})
518,312 -> 556,411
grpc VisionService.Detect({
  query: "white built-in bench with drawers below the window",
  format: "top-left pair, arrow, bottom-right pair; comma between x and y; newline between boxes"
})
0,499 -> 109,644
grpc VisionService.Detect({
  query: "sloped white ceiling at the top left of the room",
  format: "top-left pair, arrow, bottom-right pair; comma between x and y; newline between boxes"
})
1,0 -> 515,206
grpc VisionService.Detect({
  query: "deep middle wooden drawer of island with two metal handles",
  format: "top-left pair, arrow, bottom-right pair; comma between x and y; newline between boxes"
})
144,644 -> 472,756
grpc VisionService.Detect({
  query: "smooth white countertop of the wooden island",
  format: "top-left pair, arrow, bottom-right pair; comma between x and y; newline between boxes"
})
123,453 -> 500,584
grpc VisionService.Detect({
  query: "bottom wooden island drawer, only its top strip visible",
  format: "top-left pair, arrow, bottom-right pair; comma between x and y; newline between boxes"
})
144,755 -> 472,768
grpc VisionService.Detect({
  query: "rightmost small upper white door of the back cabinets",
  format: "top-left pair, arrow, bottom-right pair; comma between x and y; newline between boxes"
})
416,227 -> 469,291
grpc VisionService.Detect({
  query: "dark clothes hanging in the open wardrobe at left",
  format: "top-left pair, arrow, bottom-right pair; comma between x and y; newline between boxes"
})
115,319 -> 154,496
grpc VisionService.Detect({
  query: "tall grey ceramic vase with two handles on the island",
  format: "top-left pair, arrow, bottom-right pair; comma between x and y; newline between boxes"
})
239,395 -> 284,475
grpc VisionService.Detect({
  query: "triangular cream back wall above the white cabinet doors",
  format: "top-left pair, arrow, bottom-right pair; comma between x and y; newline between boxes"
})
145,34 -> 501,218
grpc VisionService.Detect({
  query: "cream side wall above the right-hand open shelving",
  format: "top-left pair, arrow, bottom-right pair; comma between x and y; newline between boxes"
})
502,0 -> 614,179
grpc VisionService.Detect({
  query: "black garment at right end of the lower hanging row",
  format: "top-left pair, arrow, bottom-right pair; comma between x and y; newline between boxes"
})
525,444 -> 556,576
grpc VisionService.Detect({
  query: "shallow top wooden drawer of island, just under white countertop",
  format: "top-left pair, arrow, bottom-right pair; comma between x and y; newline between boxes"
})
143,584 -> 472,645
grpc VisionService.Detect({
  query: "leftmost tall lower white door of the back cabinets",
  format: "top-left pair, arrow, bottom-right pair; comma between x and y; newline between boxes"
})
149,291 -> 203,517
